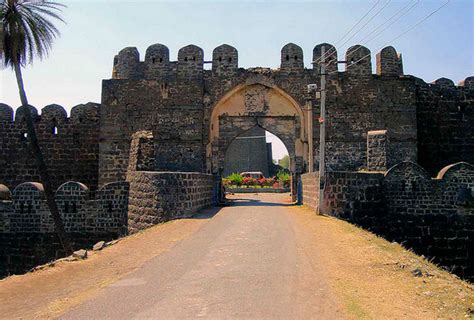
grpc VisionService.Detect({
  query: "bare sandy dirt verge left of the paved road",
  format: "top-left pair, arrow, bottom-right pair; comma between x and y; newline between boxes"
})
0,219 -> 211,319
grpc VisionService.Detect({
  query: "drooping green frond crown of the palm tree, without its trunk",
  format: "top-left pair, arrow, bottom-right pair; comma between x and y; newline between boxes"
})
0,0 -> 65,67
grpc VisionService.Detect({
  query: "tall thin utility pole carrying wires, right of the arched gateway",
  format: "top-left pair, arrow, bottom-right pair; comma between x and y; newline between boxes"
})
318,46 -> 326,214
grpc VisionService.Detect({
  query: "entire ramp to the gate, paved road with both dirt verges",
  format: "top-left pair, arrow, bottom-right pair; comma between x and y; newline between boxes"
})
0,195 -> 473,319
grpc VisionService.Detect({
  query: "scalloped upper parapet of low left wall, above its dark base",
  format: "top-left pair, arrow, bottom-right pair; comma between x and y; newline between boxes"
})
0,181 -> 129,234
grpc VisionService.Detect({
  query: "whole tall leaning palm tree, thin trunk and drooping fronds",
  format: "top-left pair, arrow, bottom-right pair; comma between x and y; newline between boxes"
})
0,0 -> 72,254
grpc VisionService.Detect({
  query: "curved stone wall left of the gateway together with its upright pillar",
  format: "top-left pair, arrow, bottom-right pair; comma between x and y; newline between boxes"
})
127,131 -> 218,233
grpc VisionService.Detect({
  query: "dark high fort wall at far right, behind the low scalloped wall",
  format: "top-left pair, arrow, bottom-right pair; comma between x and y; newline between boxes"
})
416,77 -> 474,175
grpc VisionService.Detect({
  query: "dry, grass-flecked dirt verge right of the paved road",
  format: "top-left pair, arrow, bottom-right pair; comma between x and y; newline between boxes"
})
292,207 -> 474,319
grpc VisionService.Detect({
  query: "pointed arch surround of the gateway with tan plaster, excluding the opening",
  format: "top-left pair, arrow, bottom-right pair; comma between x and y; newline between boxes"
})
206,77 -> 308,198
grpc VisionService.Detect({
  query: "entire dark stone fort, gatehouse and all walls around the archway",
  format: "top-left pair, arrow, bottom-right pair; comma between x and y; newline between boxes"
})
0,43 -> 474,275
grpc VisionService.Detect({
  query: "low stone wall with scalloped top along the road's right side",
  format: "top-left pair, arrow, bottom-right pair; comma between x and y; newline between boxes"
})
302,162 -> 474,280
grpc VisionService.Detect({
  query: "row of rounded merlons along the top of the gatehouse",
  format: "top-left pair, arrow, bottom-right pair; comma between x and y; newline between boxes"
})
112,43 -> 414,81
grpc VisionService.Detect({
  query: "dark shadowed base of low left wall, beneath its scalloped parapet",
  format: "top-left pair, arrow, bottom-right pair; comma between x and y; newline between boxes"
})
0,232 -> 122,278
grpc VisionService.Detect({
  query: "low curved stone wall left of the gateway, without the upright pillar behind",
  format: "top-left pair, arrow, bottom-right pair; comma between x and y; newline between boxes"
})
128,171 -> 217,233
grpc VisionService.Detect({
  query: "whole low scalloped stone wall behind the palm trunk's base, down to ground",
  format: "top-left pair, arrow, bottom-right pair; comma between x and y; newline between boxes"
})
0,181 -> 129,276
